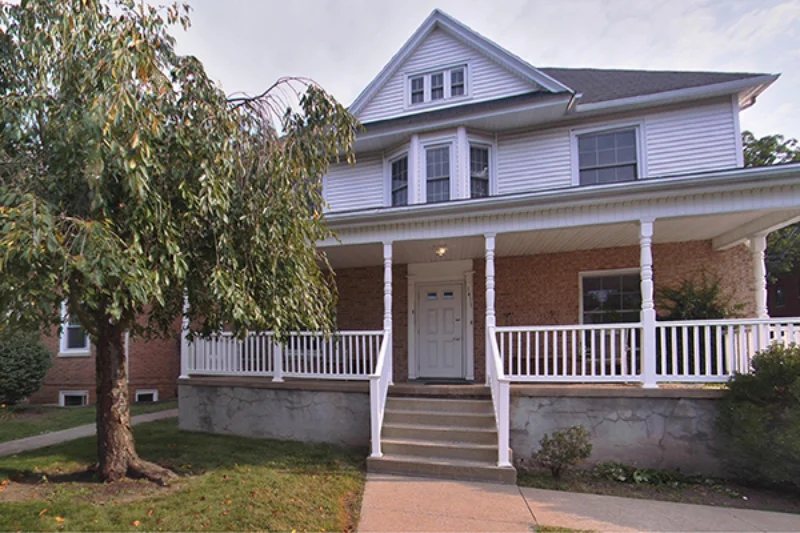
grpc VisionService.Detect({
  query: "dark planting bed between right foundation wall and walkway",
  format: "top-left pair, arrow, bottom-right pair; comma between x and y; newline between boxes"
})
517,469 -> 800,513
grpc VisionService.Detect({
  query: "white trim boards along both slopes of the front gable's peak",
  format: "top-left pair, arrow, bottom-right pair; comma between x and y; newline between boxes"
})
349,9 -> 575,116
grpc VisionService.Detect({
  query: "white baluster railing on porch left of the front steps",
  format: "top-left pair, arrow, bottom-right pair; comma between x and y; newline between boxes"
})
188,331 -> 384,381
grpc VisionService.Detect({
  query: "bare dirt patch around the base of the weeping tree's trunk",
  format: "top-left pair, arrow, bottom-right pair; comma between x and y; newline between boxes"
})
0,469 -> 185,505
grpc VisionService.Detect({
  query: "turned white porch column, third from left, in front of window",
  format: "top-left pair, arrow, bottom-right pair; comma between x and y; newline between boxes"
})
639,218 -> 658,389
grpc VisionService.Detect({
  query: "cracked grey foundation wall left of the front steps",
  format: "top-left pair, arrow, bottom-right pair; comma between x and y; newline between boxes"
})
178,384 -> 369,446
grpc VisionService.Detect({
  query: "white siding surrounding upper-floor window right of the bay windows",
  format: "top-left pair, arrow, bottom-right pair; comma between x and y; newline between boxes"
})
497,101 -> 737,194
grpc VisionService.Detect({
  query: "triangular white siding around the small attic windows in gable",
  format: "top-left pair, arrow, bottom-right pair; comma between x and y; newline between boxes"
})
358,29 -> 539,122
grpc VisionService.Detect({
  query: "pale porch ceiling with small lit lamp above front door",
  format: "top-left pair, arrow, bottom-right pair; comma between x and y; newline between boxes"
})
321,207 -> 776,268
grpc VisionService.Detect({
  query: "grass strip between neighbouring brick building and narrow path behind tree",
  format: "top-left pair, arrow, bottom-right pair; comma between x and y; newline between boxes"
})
0,400 -> 178,442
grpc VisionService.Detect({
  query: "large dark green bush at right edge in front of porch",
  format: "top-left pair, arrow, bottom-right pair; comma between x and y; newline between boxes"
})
717,344 -> 800,489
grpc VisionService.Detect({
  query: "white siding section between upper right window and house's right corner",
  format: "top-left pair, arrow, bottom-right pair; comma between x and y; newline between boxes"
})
646,101 -> 738,177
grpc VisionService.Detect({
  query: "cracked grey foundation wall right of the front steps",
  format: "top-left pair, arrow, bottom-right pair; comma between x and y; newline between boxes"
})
511,395 -> 721,474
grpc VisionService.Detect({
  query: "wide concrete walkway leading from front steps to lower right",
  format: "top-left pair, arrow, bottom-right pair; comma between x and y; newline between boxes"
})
358,474 -> 800,533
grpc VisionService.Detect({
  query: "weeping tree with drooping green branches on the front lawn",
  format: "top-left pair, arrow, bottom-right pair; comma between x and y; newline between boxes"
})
0,0 -> 358,482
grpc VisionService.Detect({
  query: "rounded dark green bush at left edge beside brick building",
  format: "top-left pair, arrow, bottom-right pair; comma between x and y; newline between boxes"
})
0,331 -> 51,405
